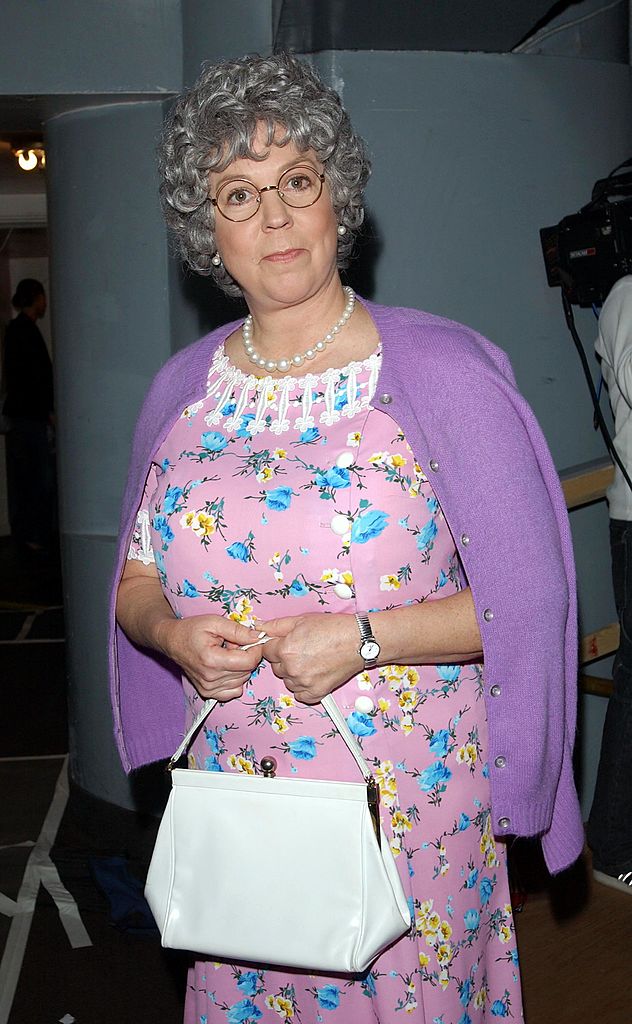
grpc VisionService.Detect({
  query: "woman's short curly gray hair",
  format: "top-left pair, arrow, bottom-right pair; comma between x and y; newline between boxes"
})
159,53 -> 371,296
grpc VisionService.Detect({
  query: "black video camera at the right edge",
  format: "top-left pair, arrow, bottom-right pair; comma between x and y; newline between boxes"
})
540,158 -> 632,306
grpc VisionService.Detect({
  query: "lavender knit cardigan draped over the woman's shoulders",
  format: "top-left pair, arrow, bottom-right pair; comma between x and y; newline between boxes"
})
110,302 -> 584,871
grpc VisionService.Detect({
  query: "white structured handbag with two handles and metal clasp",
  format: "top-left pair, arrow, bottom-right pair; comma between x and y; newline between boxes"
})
145,695 -> 411,974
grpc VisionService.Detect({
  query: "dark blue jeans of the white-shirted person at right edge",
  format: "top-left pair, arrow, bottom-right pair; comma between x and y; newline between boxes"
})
588,519 -> 632,874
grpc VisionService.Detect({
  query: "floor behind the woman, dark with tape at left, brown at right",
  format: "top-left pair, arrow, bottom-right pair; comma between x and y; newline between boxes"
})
0,538 -> 632,1024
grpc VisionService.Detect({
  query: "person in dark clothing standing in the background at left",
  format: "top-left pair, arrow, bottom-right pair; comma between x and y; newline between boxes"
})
2,278 -> 54,552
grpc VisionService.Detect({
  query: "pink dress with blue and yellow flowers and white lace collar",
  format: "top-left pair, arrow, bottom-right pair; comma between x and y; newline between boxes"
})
130,347 -> 522,1024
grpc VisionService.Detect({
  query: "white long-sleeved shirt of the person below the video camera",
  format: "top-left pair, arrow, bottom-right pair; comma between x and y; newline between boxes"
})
595,274 -> 632,519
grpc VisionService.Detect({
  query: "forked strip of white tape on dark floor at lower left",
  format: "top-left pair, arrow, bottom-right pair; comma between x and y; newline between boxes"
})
0,758 -> 92,1024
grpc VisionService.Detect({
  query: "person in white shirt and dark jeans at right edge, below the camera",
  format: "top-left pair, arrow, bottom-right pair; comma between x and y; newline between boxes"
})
587,274 -> 632,896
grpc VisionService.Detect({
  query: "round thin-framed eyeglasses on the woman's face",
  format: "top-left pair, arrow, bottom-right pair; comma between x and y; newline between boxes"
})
211,164 -> 325,221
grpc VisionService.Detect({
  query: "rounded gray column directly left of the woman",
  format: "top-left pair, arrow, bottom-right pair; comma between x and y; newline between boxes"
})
46,100 -> 171,807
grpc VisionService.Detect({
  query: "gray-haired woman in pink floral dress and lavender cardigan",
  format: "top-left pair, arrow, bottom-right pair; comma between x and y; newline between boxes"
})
111,54 -> 583,1024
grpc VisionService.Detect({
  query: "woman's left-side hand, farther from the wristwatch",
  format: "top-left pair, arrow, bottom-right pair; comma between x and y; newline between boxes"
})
156,615 -> 263,701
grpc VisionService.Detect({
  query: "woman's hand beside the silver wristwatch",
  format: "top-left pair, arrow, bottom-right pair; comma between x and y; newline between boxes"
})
261,612 -> 364,705
